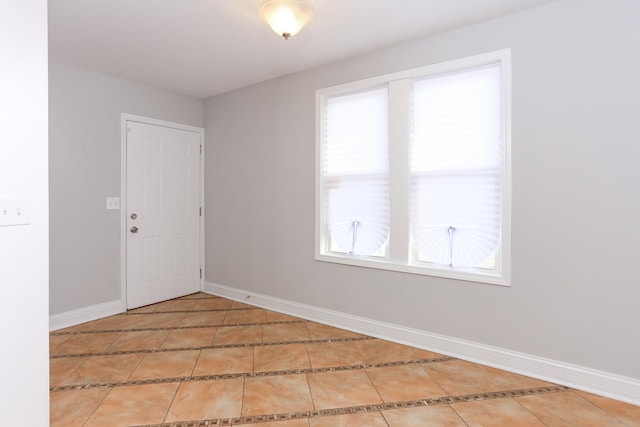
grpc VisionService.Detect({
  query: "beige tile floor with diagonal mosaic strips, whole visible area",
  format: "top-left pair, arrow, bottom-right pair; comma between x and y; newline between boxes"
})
50,293 -> 640,427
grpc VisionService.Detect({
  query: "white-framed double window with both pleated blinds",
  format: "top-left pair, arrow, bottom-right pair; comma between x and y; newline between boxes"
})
316,50 -> 511,285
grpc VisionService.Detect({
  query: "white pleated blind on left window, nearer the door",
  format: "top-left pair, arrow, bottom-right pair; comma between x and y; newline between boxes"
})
322,87 -> 389,256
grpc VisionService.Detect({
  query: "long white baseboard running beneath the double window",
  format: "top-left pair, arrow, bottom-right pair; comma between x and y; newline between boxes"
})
203,282 -> 640,405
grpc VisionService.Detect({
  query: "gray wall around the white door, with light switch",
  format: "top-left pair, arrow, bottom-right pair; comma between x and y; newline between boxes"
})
49,63 -> 203,315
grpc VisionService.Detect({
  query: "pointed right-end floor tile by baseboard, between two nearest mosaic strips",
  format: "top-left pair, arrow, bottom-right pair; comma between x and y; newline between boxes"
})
422,360 -> 551,396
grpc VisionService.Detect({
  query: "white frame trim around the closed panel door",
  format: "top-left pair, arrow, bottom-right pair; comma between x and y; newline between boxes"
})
120,113 -> 204,312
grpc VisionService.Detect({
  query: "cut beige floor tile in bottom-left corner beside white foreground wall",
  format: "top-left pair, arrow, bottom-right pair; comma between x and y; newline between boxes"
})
50,388 -> 111,427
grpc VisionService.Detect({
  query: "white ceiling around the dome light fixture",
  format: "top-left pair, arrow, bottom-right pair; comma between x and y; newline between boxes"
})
49,0 -> 551,98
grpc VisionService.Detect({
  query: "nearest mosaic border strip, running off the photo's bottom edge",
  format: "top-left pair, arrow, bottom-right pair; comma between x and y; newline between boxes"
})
126,385 -> 572,427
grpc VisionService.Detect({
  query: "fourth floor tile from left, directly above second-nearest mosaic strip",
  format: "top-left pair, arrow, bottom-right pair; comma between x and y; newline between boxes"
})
193,347 -> 253,376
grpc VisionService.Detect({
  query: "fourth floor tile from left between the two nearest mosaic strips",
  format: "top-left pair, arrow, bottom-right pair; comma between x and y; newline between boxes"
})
242,374 -> 313,416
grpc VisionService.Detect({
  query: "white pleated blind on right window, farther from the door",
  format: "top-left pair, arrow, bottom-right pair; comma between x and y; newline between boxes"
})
410,64 -> 503,268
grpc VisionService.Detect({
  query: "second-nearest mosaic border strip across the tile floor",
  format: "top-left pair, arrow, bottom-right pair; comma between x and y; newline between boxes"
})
49,357 -> 456,392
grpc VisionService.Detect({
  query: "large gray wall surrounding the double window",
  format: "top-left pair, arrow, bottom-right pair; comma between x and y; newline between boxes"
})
205,0 -> 640,378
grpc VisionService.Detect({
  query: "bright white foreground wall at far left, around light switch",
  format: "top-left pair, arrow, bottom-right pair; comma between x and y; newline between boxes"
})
0,0 -> 49,426
